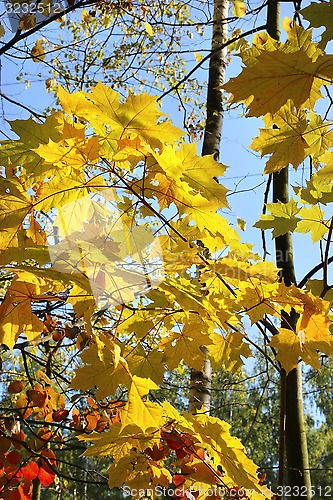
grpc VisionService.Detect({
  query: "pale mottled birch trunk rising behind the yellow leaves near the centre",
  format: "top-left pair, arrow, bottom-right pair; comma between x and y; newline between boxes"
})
189,0 -> 229,413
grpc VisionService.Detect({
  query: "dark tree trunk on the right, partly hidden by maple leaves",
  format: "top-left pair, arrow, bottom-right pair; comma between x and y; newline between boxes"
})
267,0 -> 312,500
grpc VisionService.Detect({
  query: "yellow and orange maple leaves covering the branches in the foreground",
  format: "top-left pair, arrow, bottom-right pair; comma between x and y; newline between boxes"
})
0,11 -> 333,500
